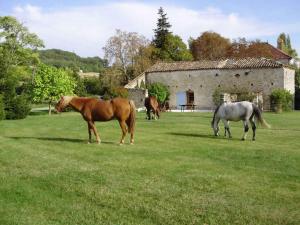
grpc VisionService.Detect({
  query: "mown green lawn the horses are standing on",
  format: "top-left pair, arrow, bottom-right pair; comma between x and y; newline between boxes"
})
0,112 -> 300,225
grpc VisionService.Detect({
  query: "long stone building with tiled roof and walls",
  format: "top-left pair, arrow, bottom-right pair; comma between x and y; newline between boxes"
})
145,58 -> 295,110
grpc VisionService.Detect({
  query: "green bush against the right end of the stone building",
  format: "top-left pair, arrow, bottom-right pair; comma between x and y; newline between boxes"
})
270,89 -> 293,112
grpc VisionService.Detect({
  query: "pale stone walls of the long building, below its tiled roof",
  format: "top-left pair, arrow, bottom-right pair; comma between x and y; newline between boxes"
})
146,67 -> 294,110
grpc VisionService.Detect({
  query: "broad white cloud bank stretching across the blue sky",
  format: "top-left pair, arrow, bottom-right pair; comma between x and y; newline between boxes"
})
13,2 -> 286,56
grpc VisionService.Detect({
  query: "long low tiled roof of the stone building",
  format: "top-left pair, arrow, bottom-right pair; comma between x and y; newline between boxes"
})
146,58 -> 285,73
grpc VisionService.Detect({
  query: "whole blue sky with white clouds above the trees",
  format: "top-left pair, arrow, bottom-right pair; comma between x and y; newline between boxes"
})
0,0 -> 300,57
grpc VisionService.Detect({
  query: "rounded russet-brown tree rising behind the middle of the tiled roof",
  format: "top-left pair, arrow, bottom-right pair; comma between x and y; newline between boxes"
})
190,31 -> 231,60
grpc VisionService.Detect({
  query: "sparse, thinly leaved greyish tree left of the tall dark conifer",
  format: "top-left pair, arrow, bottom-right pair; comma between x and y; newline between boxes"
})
103,30 -> 149,83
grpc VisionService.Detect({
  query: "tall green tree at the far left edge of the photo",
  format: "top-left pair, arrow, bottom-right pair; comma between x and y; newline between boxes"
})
0,16 -> 43,119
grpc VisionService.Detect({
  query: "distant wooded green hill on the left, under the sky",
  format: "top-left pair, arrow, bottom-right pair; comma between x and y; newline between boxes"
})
38,49 -> 107,72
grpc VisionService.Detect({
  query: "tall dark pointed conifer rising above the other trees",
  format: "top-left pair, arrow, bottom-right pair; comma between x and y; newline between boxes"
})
153,7 -> 171,49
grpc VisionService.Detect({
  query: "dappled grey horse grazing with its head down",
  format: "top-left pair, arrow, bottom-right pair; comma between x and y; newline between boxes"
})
211,101 -> 270,141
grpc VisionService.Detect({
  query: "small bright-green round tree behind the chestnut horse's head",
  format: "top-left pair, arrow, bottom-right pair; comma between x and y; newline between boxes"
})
33,64 -> 75,115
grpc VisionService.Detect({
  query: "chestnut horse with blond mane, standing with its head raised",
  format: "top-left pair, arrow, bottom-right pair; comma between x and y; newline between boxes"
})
55,96 -> 135,144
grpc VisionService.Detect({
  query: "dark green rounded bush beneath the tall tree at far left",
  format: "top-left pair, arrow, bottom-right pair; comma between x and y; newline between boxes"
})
5,95 -> 31,120
